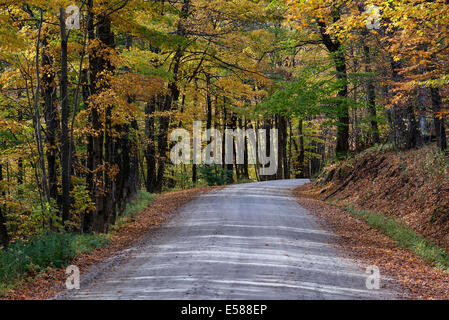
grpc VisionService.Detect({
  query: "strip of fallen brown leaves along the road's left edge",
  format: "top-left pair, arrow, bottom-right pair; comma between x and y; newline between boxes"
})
0,187 -> 216,300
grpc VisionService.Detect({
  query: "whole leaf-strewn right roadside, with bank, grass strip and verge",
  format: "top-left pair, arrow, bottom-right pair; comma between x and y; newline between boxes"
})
295,146 -> 449,299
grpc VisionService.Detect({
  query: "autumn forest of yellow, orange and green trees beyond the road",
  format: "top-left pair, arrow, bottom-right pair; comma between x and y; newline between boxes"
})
0,0 -> 449,247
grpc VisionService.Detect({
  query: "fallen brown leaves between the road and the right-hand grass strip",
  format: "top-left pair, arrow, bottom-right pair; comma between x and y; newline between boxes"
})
295,184 -> 449,300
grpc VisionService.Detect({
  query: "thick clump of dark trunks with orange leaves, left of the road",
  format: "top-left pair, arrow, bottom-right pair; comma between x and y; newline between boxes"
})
83,0 -> 139,232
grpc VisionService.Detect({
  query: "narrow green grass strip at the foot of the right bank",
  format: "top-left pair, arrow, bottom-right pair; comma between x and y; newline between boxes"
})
344,208 -> 449,271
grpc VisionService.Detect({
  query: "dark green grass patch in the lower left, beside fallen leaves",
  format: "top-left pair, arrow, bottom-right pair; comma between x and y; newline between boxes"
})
0,233 -> 109,297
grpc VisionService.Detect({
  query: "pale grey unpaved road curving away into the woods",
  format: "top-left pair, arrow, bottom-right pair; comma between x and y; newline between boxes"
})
65,180 -> 395,300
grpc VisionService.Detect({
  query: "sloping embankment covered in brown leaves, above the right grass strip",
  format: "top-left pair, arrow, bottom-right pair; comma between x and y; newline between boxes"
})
300,146 -> 449,252
